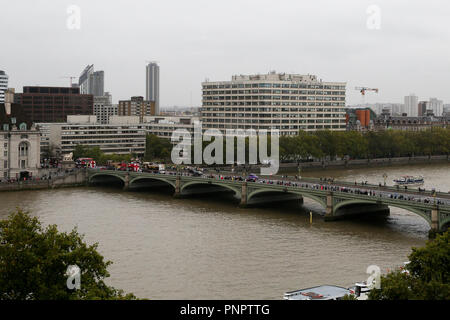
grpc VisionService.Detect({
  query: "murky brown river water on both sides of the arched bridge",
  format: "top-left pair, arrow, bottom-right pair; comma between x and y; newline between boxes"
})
0,163 -> 450,299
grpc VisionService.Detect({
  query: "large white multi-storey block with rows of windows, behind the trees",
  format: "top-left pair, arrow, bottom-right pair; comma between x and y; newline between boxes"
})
201,72 -> 346,135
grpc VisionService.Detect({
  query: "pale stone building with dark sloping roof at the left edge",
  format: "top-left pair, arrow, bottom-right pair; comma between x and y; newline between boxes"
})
0,90 -> 40,181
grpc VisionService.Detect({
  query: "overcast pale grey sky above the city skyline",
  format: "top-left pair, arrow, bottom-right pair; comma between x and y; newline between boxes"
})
0,0 -> 450,107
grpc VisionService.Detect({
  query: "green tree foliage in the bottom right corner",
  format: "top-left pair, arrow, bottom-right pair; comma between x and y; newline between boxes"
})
369,231 -> 450,300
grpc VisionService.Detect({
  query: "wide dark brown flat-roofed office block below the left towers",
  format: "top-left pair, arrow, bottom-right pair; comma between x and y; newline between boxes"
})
15,87 -> 94,123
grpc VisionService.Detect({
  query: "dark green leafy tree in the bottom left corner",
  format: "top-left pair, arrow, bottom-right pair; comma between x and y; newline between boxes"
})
0,209 -> 136,300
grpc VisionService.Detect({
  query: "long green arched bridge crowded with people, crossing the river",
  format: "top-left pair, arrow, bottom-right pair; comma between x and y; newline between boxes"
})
87,169 -> 450,233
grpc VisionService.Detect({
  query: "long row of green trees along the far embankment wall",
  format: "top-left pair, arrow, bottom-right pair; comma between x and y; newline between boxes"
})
280,128 -> 450,161
